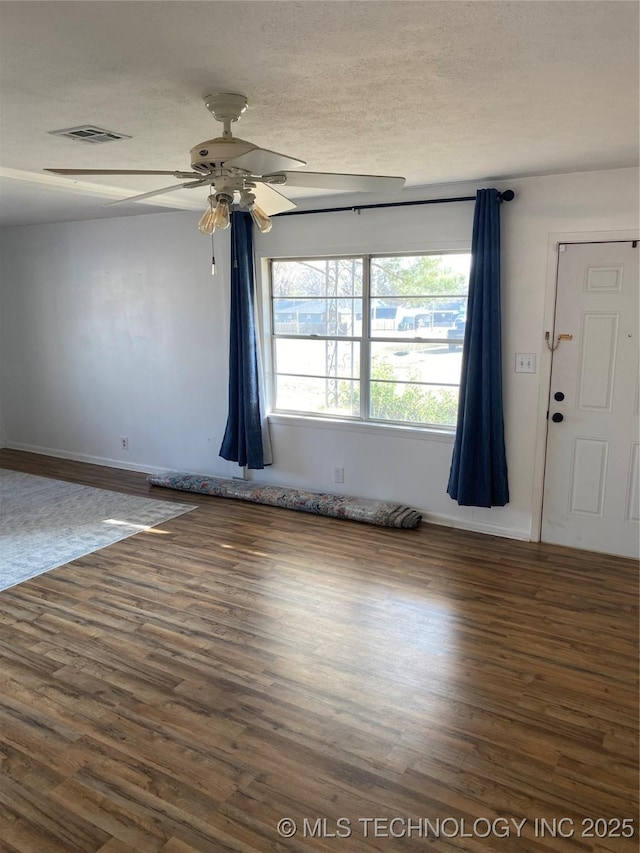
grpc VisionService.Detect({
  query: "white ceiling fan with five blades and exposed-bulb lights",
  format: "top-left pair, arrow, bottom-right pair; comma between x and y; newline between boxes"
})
44,93 -> 405,234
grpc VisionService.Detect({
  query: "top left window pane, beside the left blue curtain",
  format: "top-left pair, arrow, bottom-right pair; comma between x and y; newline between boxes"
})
271,258 -> 362,298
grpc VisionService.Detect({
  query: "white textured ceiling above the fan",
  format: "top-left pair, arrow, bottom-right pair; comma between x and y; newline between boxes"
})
0,0 -> 639,224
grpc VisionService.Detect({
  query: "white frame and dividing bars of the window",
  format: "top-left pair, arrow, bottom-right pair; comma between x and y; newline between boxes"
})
261,246 -> 471,432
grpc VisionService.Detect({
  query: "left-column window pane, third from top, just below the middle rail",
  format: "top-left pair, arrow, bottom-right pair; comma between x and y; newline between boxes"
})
275,338 -> 360,378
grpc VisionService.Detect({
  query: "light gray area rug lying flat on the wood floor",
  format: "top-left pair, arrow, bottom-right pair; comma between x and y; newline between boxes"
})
0,468 -> 195,590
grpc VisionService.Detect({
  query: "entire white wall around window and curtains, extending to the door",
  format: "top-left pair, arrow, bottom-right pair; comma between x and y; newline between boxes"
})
0,169 -> 638,538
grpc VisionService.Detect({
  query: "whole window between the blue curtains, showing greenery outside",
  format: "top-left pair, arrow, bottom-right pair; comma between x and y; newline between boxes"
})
270,253 -> 471,427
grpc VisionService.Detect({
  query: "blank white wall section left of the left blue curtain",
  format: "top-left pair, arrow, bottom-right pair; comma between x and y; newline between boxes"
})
0,213 -> 238,474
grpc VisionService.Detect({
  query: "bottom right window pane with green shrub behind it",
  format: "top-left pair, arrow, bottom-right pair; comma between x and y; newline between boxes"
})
371,381 -> 458,427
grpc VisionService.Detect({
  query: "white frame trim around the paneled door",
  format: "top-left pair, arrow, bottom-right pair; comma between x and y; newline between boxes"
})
531,229 -> 640,542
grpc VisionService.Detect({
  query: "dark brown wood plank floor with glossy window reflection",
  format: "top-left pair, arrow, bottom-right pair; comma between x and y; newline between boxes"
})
0,450 -> 638,853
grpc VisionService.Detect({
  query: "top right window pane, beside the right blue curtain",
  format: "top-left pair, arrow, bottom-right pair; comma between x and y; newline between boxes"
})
371,254 -> 471,296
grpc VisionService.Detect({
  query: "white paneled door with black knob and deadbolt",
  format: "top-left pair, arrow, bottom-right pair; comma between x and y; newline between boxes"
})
542,241 -> 640,557
